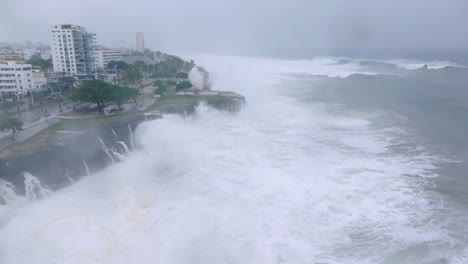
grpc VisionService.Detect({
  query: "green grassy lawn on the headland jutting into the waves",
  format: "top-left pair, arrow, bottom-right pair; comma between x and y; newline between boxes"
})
147,95 -> 230,111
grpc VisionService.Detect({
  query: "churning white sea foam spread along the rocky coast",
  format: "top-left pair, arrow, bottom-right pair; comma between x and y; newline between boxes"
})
0,54 -> 460,264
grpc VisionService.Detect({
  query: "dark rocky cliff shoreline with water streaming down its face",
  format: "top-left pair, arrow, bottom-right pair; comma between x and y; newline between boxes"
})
0,92 -> 245,197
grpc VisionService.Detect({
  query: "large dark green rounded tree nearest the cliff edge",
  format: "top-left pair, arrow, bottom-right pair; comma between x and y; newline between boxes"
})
71,80 -> 112,114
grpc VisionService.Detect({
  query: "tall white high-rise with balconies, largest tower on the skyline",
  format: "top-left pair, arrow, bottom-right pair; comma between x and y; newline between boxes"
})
50,24 -> 96,76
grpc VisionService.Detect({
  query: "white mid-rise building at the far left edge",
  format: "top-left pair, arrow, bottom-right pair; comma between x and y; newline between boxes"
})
0,61 -> 35,99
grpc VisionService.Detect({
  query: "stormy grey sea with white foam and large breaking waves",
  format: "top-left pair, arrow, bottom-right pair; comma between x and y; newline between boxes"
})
0,55 -> 468,264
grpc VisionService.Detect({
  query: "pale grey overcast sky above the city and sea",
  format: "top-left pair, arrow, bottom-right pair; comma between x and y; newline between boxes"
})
0,0 -> 468,54
